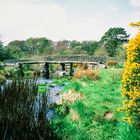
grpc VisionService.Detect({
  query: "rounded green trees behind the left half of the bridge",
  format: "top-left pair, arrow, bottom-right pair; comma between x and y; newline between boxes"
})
6,37 -> 49,59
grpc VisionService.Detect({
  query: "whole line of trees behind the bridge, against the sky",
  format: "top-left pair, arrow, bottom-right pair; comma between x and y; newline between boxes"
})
0,27 -> 129,61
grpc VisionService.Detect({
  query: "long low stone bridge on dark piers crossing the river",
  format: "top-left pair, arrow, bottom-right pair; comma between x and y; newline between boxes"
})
5,56 -> 105,79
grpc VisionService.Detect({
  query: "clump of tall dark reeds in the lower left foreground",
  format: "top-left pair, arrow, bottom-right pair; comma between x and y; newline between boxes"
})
0,80 -> 59,140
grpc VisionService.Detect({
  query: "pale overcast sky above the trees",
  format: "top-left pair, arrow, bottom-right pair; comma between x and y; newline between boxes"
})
0,0 -> 140,43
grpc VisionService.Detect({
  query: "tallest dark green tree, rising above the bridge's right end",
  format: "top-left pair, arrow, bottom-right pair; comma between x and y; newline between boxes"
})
101,27 -> 129,57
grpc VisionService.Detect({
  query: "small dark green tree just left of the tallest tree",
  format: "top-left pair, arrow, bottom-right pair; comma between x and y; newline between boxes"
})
81,41 -> 99,55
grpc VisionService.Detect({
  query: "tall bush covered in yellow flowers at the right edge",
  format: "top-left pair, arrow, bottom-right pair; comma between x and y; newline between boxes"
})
118,22 -> 140,125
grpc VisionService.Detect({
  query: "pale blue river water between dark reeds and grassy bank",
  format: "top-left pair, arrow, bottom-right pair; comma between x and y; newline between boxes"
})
1,77 -> 63,121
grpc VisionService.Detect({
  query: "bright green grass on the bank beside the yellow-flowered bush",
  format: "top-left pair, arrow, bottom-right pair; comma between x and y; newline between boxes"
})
53,69 -> 139,140
